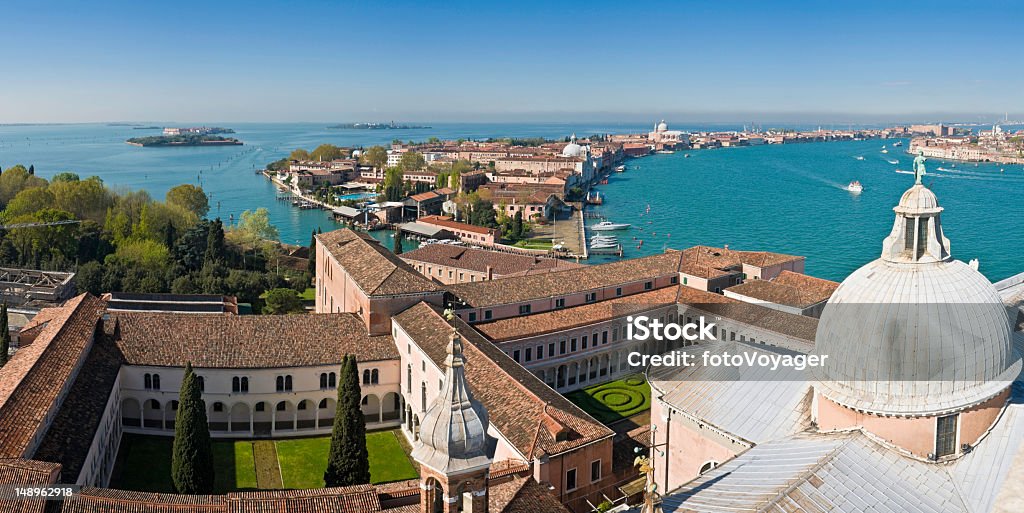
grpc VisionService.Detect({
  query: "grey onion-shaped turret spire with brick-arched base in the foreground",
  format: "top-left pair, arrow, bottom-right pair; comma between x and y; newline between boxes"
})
412,311 -> 490,513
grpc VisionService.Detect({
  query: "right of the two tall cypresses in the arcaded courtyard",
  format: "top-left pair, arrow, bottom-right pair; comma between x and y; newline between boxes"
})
324,354 -> 370,486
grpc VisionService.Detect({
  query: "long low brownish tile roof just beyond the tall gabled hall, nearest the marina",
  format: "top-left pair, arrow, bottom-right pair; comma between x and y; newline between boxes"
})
401,244 -> 582,276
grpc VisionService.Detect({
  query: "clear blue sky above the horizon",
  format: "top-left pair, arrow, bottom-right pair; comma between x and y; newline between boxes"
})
0,0 -> 1024,123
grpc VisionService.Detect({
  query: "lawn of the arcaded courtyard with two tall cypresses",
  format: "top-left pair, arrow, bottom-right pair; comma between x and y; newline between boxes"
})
111,431 -> 419,494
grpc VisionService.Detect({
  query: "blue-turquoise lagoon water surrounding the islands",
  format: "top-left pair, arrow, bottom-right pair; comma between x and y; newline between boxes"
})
0,122 -> 1024,280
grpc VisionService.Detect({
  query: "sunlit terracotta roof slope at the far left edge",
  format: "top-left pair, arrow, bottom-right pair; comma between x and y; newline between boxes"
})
0,294 -> 103,458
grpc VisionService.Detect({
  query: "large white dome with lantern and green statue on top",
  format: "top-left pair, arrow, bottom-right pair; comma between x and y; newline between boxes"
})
814,172 -> 1021,416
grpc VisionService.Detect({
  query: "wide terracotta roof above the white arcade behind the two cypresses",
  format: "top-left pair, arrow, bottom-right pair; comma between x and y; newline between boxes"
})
114,312 -> 398,369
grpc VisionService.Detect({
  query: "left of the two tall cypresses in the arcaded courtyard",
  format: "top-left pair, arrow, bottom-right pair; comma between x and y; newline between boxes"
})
171,361 -> 213,494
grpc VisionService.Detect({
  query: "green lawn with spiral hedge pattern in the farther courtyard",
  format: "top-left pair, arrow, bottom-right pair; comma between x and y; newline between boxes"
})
565,374 -> 650,424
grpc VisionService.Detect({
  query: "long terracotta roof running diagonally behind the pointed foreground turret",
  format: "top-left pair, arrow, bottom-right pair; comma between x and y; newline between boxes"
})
394,302 -> 614,459
